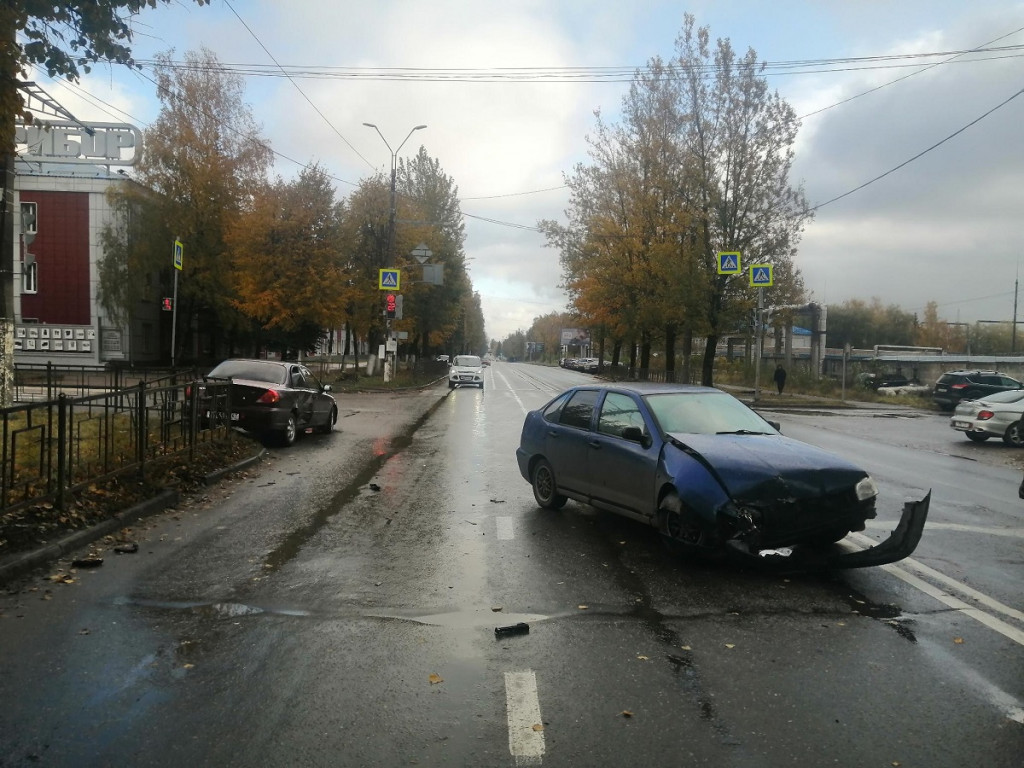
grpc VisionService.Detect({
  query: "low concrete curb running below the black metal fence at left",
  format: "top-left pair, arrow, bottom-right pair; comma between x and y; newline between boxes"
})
0,447 -> 267,584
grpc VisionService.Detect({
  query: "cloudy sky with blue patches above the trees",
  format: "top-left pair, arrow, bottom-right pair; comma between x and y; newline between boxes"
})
33,0 -> 1024,339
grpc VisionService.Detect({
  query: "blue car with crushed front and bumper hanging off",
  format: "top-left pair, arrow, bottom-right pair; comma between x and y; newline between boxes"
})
516,384 -> 930,567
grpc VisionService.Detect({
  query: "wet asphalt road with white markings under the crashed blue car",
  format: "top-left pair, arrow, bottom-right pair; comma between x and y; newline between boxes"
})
0,365 -> 1024,766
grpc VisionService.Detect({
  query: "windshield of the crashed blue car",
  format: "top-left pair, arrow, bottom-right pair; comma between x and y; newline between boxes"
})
644,392 -> 775,434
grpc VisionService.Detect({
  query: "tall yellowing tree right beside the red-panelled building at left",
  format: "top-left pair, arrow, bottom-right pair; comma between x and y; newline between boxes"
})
99,49 -> 271,361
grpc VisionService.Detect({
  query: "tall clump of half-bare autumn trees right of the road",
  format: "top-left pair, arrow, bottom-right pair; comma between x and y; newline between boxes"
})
541,14 -> 810,385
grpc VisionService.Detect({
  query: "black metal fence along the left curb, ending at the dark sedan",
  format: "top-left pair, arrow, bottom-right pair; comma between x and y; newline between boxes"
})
0,381 -> 232,518
